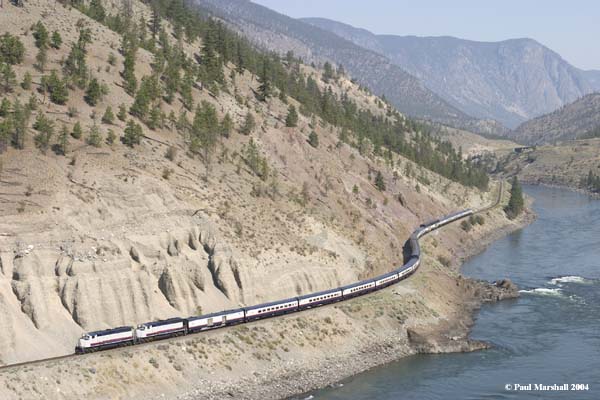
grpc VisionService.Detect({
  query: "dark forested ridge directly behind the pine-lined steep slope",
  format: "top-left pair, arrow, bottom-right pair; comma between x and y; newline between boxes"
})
195,0 -> 506,133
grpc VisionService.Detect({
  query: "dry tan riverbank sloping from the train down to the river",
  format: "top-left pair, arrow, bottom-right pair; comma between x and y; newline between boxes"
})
0,188 -> 530,400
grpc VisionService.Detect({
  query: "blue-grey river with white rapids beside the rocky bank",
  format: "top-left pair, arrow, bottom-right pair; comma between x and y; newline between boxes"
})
308,186 -> 600,400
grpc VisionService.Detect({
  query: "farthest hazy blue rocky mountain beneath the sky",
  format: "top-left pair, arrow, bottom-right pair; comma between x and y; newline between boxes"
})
302,18 -> 600,128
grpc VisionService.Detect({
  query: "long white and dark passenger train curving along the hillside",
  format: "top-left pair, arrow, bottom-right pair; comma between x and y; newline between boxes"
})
75,209 -> 473,354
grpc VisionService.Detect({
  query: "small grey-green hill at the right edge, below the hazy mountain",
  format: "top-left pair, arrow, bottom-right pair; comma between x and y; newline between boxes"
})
509,93 -> 600,144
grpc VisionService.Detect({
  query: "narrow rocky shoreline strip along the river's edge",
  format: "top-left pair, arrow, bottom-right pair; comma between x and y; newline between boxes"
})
177,210 -> 535,400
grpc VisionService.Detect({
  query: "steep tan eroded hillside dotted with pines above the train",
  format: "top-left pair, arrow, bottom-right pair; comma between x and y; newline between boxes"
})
0,1 -> 494,364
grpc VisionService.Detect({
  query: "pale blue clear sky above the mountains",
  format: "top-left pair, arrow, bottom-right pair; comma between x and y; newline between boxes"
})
252,0 -> 600,70
